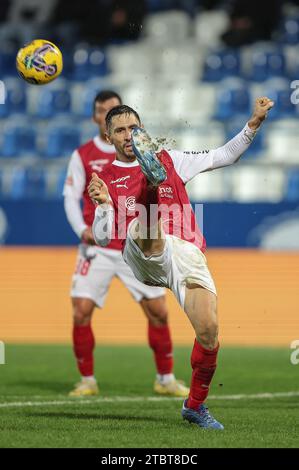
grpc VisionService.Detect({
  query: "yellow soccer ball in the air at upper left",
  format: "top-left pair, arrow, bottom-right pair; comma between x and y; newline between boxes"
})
16,39 -> 63,85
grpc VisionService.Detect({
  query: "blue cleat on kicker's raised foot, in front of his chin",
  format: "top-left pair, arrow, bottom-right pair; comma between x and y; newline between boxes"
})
132,127 -> 166,186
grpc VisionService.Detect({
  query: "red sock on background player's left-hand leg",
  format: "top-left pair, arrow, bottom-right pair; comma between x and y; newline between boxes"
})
73,324 -> 95,377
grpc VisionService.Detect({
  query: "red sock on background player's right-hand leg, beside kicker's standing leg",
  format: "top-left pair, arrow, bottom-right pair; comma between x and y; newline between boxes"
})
148,323 -> 173,375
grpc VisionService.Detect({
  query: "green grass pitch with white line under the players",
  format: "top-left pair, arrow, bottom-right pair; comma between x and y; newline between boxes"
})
0,344 -> 299,448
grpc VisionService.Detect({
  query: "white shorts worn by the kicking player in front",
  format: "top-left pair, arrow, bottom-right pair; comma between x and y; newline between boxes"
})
123,224 -> 217,308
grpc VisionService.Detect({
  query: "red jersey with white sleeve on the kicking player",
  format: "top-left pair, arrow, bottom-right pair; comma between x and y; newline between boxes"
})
99,150 -> 212,251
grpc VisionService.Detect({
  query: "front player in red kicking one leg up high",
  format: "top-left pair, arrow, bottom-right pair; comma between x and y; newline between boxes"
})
89,97 -> 274,430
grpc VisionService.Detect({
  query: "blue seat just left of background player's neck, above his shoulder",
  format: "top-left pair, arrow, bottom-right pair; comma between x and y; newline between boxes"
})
43,126 -> 80,158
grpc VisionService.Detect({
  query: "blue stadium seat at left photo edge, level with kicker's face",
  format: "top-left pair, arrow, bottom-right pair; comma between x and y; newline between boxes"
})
0,124 -> 36,157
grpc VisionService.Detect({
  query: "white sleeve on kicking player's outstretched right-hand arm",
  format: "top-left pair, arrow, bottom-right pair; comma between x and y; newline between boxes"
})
168,124 -> 256,183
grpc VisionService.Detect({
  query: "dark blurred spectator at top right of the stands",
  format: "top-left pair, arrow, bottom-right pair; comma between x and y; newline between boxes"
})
222,0 -> 283,47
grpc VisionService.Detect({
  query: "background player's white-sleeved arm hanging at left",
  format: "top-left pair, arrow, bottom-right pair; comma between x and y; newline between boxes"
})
63,151 -> 94,244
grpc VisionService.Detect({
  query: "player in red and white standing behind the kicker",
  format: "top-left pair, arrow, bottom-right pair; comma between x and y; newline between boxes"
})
63,90 -> 189,396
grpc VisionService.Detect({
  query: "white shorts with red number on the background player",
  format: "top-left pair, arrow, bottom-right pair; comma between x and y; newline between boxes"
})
71,245 -> 165,307
